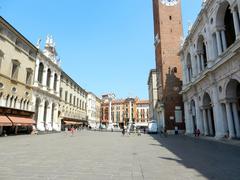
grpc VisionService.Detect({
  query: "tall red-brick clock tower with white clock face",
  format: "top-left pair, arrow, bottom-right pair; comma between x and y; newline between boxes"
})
153,0 -> 185,132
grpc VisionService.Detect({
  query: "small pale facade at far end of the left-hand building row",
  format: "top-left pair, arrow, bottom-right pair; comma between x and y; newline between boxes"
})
87,92 -> 101,128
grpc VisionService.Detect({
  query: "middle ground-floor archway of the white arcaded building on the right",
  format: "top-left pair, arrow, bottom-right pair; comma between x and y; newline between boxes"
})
203,93 -> 216,136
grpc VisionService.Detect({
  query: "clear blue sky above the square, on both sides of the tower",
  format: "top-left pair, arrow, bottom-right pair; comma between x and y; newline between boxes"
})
0,0 -> 202,99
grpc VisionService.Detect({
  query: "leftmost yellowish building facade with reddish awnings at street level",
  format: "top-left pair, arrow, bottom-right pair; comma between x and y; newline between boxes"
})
0,17 -> 37,135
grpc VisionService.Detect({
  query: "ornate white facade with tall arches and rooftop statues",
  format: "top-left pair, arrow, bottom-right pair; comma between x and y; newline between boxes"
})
33,36 -> 61,131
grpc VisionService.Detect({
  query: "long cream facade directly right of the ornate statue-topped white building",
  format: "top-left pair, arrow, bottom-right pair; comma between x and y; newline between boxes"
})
59,71 -> 88,130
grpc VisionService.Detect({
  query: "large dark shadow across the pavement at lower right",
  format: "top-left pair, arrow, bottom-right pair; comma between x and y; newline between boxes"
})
150,135 -> 240,180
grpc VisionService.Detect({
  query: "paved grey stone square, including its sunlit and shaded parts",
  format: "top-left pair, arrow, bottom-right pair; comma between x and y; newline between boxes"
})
0,131 -> 240,180
